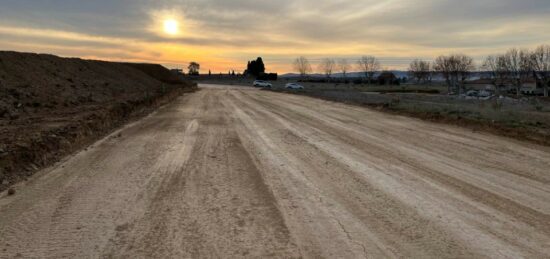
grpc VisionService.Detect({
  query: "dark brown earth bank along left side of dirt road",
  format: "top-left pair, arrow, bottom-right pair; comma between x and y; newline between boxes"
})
0,52 -> 196,191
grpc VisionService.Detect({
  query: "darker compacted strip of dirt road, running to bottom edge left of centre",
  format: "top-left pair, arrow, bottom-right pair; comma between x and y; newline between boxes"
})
101,89 -> 299,258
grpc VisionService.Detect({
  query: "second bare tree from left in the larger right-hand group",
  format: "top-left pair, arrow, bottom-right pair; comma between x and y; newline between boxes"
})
434,54 -> 475,93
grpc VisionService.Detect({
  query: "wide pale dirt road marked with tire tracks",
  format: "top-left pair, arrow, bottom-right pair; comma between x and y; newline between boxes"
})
0,85 -> 550,258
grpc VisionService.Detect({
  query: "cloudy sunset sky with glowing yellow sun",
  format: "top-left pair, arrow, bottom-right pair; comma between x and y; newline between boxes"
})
0,0 -> 550,73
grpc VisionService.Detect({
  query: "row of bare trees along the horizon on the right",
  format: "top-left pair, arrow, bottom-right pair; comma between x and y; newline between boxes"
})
293,45 -> 550,96
